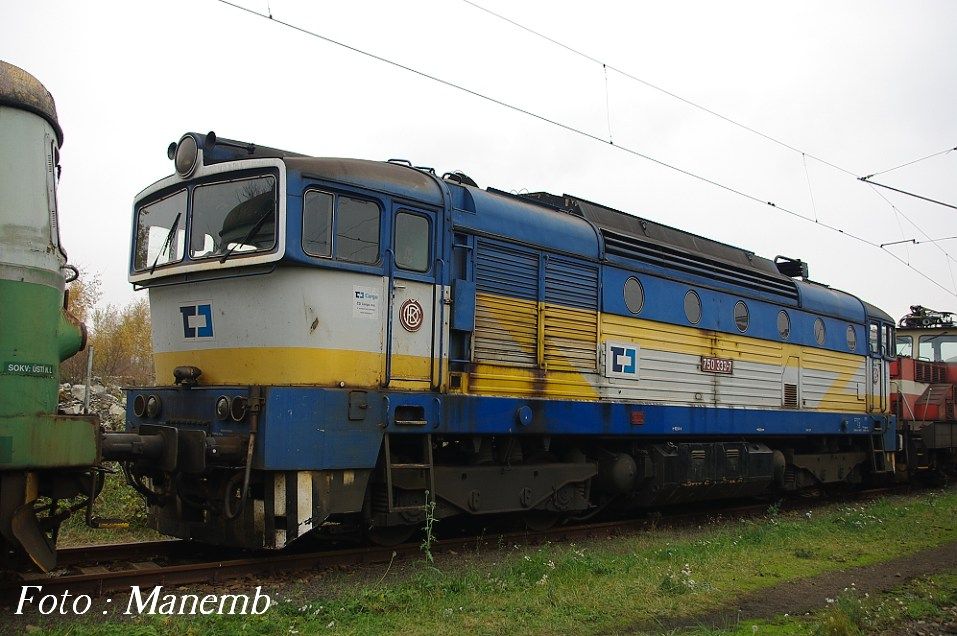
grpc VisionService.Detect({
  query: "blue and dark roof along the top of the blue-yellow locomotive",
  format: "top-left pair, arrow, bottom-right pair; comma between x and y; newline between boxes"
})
155,133 -> 893,322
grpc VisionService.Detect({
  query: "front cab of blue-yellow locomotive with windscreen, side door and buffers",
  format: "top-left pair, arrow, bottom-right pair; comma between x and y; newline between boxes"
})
118,133 -> 448,547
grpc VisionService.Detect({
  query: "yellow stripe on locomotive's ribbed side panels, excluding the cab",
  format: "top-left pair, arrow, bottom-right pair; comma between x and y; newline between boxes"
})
468,294 -> 865,412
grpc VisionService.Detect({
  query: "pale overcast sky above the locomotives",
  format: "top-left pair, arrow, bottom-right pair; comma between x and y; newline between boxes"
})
0,0 -> 957,318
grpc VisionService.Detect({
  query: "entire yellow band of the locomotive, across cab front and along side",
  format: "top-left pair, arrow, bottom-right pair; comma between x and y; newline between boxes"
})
154,294 -> 865,412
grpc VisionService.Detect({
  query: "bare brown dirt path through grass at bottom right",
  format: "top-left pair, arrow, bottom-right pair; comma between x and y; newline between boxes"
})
635,542 -> 957,633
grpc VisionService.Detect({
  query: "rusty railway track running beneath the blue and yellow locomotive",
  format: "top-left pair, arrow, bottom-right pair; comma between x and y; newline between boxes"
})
0,488 -> 904,603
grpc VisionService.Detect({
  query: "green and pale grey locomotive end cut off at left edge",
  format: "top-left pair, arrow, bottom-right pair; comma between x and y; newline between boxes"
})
0,61 -> 100,570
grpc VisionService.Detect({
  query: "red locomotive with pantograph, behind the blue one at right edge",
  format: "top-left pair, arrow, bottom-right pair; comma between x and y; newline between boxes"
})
888,305 -> 957,477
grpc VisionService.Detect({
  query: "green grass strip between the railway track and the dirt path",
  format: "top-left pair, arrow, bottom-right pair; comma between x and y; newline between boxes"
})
18,492 -> 957,635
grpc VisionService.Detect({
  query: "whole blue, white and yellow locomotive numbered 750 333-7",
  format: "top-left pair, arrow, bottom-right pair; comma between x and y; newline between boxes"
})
119,133 -> 896,548
